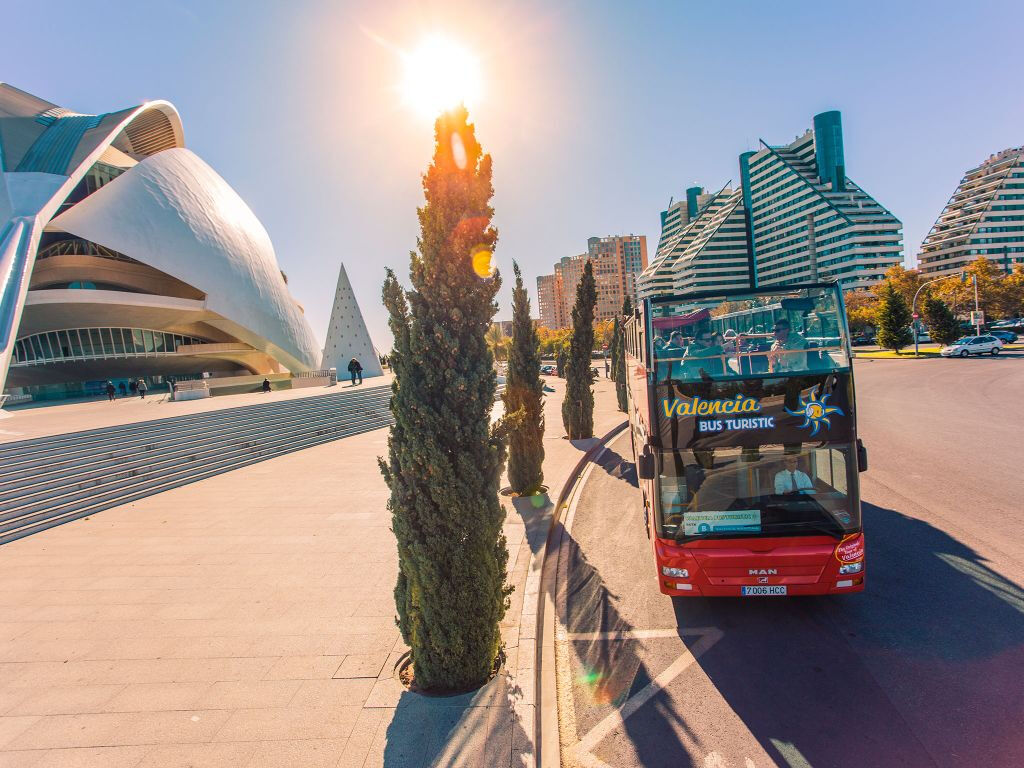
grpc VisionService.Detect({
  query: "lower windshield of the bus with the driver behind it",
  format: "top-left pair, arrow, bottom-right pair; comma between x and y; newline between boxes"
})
657,443 -> 860,542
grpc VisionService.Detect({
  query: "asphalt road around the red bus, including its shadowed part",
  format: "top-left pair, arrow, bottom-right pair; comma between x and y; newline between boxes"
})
559,357 -> 1024,768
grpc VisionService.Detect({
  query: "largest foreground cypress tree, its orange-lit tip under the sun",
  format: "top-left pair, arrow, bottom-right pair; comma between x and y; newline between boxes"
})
380,108 -> 510,689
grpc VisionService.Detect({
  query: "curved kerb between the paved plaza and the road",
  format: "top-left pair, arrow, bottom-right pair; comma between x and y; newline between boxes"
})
534,421 -> 629,768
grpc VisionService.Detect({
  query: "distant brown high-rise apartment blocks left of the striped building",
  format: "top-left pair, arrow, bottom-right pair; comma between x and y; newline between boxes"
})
537,234 -> 647,329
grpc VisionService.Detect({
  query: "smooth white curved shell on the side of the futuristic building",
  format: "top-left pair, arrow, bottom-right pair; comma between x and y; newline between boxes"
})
52,148 -> 321,371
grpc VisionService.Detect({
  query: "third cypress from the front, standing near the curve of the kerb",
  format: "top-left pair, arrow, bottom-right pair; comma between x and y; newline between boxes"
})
562,260 -> 597,440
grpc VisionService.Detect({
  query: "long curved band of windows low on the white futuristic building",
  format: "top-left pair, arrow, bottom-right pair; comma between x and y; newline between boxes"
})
11,328 -> 208,366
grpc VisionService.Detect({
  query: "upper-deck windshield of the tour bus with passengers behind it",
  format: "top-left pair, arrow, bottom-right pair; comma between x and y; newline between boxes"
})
651,286 -> 850,382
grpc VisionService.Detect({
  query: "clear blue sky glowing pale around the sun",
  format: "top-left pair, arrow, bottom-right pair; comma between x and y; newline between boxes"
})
0,0 -> 1024,347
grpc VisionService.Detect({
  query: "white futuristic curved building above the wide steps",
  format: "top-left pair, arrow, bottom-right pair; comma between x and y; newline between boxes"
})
0,84 -> 322,396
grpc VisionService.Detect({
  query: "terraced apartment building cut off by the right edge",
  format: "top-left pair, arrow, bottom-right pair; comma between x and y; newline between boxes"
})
918,146 -> 1024,276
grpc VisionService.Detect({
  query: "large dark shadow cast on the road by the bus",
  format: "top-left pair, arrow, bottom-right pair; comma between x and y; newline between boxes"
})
674,503 -> 1024,768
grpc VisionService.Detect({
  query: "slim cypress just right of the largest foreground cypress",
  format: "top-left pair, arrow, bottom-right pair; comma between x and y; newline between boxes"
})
503,261 -> 544,496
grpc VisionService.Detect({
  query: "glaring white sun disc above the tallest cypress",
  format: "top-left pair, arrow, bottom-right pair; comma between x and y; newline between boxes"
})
401,36 -> 480,120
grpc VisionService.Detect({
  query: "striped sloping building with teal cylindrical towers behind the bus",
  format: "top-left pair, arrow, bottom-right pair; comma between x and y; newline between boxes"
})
640,112 -> 902,296
